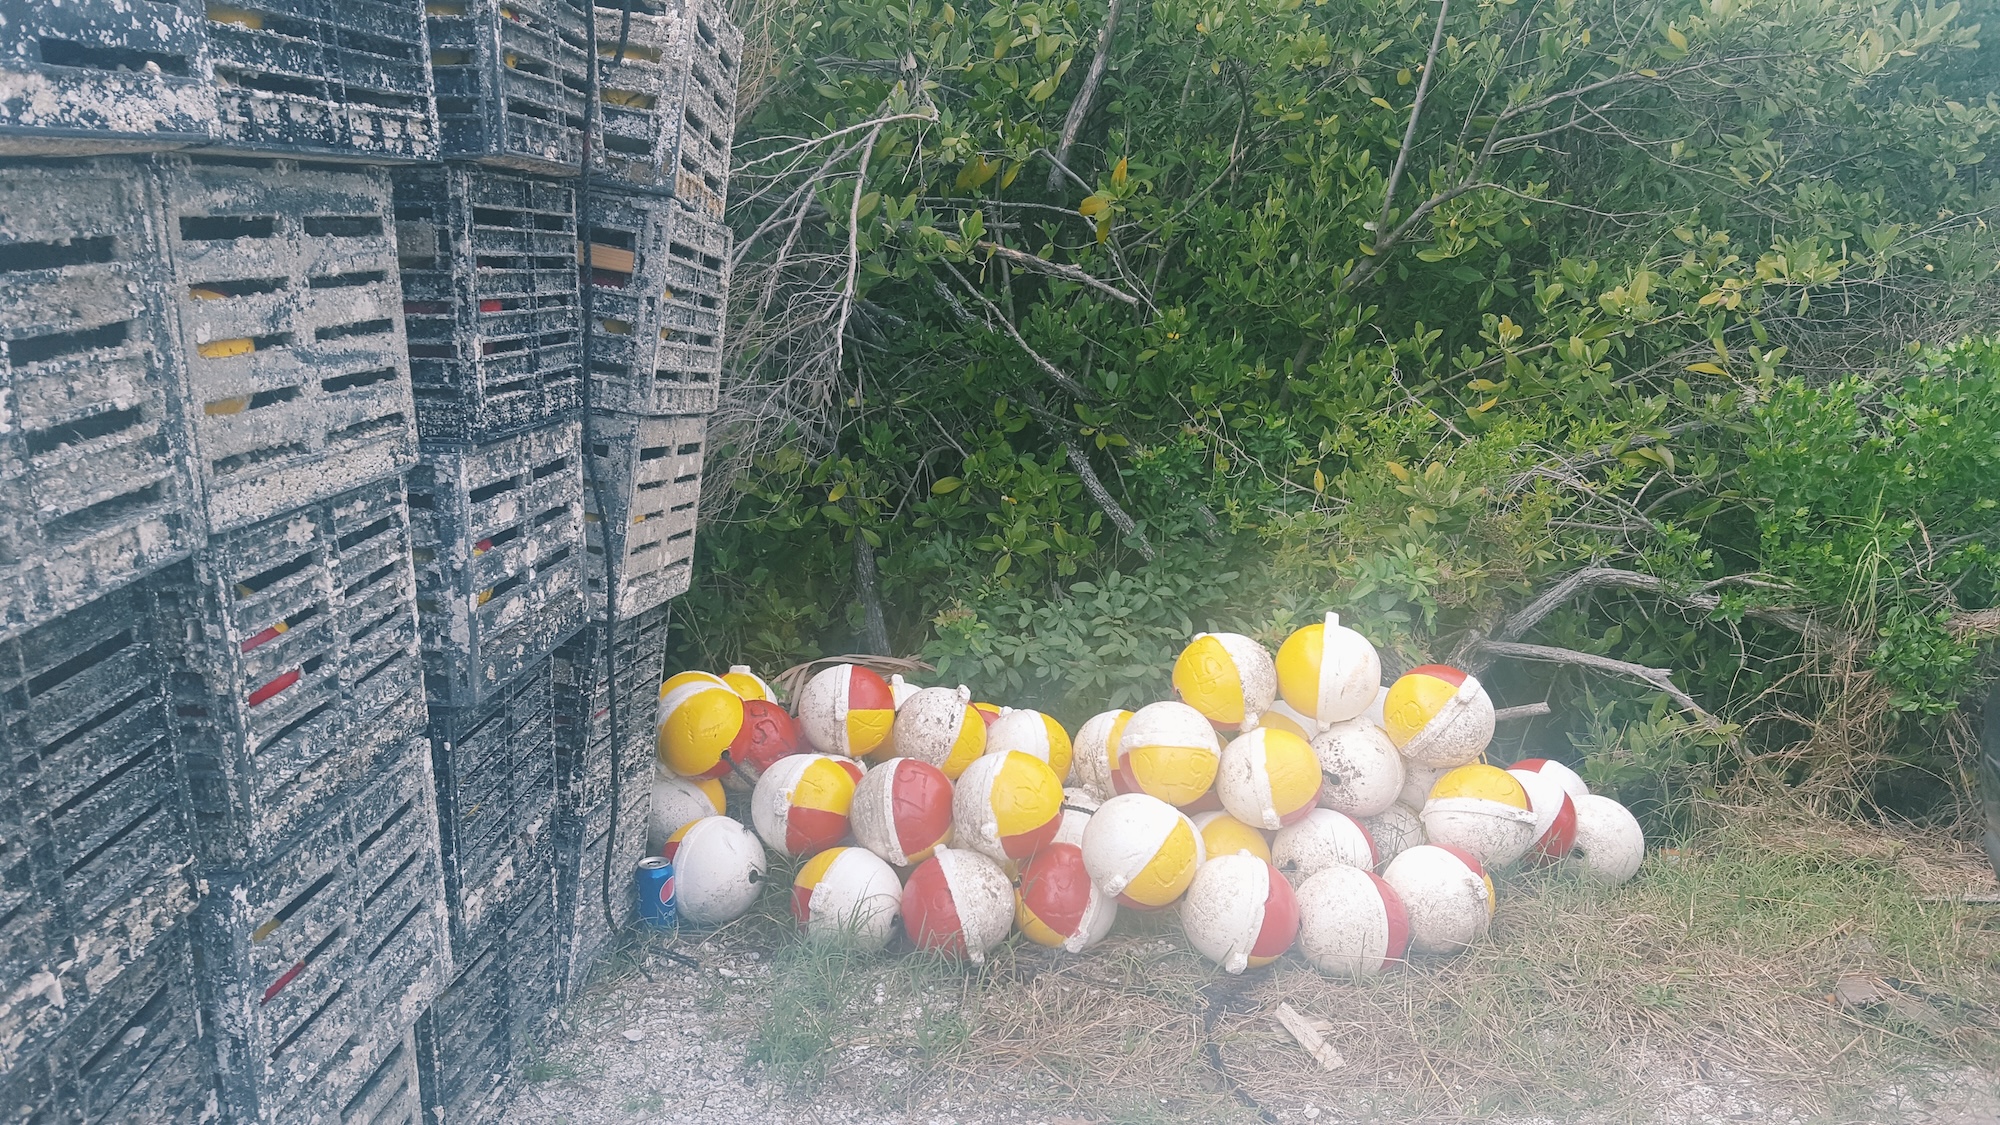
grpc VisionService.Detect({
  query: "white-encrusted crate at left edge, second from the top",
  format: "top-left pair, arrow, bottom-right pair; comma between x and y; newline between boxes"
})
0,155 -> 194,635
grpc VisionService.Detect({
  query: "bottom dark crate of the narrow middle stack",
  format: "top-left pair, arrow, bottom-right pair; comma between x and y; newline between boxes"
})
416,876 -> 562,1125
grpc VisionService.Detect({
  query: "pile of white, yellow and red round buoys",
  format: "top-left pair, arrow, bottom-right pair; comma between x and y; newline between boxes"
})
648,613 -> 1646,977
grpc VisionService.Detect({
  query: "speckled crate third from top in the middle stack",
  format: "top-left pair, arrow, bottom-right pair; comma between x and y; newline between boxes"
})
410,422 -> 584,709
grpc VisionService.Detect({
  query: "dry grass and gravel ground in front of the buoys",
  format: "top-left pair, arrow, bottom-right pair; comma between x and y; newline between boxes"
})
572,803 -> 2000,1125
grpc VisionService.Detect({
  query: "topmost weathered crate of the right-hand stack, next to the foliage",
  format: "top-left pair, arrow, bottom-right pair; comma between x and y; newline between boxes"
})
596,0 -> 744,218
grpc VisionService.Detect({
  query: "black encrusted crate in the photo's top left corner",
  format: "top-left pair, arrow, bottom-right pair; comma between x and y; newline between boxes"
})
0,0 -> 216,156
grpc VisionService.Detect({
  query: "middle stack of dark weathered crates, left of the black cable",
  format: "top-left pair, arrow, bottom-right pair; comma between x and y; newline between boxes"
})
394,133 -> 588,1121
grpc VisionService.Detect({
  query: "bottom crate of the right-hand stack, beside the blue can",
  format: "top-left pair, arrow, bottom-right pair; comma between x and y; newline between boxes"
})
556,769 -> 652,1001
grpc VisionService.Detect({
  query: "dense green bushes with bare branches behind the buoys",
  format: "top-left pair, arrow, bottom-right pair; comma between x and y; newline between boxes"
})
674,0 -> 2000,813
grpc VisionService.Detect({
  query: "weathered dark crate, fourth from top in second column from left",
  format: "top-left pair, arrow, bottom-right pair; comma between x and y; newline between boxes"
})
194,739 -> 452,1123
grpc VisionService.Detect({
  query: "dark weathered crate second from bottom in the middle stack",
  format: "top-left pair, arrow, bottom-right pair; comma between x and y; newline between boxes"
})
430,661 -> 556,957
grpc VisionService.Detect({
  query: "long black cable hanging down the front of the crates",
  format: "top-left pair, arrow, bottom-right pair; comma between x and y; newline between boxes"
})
576,0 -> 632,929
